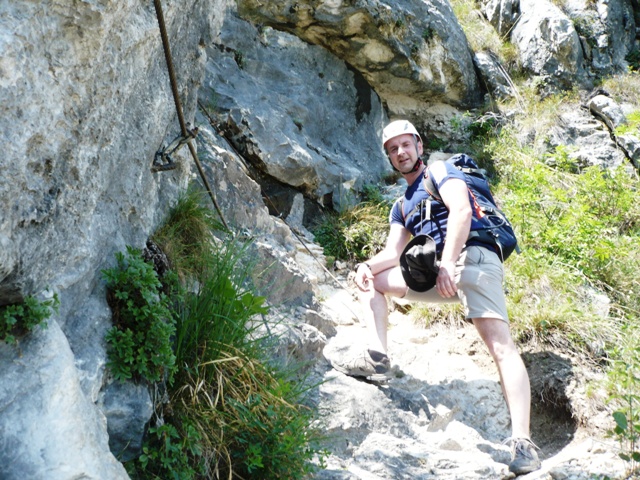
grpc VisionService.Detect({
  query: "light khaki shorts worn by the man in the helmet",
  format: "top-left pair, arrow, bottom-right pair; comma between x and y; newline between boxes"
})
403,246 -> 509,322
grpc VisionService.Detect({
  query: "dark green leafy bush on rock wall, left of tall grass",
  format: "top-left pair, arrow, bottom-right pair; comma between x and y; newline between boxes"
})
102,247 -> 175,382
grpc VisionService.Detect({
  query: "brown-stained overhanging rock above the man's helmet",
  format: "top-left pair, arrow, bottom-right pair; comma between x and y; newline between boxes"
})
238,0 -> 482,121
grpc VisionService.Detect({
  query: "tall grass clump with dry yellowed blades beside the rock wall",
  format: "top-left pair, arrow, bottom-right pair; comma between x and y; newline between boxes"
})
126,228 -> 323,480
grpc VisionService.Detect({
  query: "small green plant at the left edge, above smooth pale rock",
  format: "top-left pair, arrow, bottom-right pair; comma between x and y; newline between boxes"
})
0,294 -> 60,344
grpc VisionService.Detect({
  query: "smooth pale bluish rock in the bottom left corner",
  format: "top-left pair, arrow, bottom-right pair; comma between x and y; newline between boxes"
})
0,320 -> 129,480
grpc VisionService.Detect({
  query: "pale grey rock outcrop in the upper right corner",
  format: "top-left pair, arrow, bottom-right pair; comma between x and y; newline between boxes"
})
480,0 -> 638,88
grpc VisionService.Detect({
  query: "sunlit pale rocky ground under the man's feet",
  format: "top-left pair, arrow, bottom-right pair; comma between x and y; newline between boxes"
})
302,270 -> 626,480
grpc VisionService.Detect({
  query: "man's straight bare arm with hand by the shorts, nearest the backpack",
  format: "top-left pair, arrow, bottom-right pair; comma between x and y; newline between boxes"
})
436,178 -> 471,298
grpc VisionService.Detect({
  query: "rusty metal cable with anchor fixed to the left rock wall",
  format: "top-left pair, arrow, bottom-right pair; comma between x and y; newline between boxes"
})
152,0 -> 229,229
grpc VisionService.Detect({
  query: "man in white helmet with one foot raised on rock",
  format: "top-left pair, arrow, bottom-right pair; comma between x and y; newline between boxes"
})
334,120 -> 540,475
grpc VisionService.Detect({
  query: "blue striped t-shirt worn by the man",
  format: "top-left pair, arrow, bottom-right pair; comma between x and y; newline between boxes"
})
389,161 -> 471,253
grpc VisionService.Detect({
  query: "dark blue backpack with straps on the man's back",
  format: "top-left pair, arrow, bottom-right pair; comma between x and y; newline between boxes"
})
401,153 -> 520,262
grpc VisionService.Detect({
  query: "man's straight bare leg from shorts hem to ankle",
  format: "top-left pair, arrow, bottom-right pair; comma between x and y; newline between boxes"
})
473,318 -> 531,438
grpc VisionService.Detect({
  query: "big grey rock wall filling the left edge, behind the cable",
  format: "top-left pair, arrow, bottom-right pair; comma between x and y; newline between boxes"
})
0,0 -> 229,479
